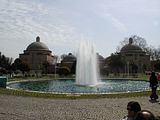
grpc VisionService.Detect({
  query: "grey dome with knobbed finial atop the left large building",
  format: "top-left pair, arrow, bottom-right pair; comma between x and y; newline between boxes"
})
27,36 -> 49,51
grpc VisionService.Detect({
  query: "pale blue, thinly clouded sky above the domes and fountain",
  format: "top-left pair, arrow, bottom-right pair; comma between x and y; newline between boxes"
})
0,0 -> 160,59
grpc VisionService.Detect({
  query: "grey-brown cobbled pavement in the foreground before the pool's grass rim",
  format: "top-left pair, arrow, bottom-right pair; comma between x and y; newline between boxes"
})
0,94 -> 160,120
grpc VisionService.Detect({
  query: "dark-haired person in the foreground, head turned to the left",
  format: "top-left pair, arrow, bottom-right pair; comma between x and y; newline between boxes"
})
122,101 -> 141,120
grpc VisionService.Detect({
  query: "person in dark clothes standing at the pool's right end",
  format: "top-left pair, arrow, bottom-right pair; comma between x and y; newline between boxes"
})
149,72 -> 158,100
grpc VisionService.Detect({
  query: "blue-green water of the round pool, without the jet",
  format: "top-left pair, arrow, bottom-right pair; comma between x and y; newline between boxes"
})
8,79 -> 149,94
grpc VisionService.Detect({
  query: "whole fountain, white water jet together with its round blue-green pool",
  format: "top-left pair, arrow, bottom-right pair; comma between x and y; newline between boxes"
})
7,41 -> 149,94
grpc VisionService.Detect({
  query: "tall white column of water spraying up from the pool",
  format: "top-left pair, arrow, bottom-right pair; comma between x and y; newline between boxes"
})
76,41 -> 98,86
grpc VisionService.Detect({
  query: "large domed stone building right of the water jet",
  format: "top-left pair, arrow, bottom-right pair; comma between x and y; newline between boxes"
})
120,38 -> 150,72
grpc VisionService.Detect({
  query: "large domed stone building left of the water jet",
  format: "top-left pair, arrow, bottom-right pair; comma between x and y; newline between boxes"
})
19,36 -> 54,71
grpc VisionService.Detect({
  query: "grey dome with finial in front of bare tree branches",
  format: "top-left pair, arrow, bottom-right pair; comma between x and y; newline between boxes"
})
121,38 -> 142,52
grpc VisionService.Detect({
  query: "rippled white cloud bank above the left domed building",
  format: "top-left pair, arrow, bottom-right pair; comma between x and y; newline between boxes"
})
0,0 -> 82,58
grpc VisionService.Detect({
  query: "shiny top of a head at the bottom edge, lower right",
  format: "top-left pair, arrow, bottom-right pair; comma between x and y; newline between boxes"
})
134,110 -> 156,120
